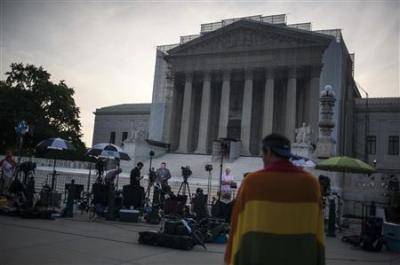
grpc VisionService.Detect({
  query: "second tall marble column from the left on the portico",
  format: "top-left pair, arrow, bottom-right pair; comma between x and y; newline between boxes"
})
195,71 -> 211,154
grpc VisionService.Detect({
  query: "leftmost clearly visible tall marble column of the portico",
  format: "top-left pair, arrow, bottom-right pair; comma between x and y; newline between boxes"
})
177,73 -> 193,153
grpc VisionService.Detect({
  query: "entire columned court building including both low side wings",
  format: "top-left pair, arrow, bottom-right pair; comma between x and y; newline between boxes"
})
93,15 -> 400,212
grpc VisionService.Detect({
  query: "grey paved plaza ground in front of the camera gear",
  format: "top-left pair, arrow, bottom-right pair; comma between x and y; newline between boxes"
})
0,216 -> 400,265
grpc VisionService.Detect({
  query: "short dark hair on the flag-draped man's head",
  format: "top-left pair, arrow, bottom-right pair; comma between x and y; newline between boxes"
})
262,133 -> 292,159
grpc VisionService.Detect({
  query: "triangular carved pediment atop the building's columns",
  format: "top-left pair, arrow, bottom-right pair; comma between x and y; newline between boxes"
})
168,20 -> 332,56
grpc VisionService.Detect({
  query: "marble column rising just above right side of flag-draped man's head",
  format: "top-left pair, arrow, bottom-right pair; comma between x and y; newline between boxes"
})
285,67 -> 297,143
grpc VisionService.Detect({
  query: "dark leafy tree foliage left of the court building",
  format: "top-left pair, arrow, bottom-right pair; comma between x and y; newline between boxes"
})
0,63 -> 85,157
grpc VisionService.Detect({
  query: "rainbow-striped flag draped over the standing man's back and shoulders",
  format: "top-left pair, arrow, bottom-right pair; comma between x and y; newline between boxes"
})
225,160 -> 325,265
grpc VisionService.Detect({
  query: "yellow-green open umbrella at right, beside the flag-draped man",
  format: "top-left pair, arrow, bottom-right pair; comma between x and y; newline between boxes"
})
315,156 -> 375,174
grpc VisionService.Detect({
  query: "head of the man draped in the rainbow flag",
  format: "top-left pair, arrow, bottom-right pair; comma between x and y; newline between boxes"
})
262,133 -> 293,165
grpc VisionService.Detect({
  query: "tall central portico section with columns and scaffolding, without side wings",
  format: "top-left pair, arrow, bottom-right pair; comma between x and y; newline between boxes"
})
149,15 -> 360,156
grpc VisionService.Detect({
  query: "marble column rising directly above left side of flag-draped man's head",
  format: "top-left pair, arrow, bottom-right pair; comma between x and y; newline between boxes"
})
261,69 -> 274,138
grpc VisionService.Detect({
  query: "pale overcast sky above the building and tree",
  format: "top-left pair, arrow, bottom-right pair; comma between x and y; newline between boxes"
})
0,0 -> 400,145
